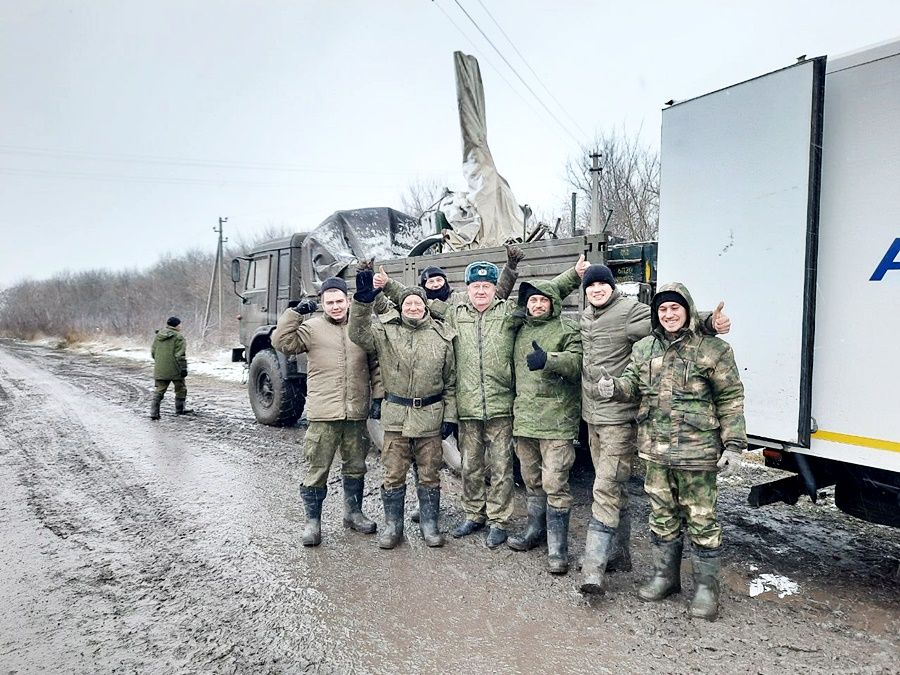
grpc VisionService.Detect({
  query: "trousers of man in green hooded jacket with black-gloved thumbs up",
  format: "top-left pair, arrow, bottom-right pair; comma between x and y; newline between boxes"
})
516,436 -> 575,509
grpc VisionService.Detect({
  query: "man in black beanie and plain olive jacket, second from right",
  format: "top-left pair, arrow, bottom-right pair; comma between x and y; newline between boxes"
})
579,265 -> 731,593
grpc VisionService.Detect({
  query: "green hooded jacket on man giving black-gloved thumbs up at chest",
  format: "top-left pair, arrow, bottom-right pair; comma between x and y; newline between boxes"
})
513,272 -> 581,439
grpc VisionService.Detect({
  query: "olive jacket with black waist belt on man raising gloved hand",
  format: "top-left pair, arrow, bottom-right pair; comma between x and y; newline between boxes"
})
350,300 -> 457,438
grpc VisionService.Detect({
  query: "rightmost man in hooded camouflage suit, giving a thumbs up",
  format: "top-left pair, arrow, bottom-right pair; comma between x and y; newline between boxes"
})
597,283 -> 747,621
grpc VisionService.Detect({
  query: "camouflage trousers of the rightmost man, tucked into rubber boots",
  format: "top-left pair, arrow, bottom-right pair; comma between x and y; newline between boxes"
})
644,460 -> 722,548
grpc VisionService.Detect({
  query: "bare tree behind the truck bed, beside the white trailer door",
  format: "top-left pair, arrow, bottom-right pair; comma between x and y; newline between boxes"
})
564,131 -> 659,242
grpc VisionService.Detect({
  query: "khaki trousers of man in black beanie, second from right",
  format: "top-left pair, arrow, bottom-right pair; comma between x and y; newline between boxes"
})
588,422 -> 637,529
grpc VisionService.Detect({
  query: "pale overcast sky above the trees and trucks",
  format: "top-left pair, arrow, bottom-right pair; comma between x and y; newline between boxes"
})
0,0 -> 900,287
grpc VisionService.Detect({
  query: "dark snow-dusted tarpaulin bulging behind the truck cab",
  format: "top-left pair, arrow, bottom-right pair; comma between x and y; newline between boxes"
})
300,208 -> 430,295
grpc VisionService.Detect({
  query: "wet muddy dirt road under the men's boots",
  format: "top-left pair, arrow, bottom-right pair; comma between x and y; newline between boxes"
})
0,341 -> 900,673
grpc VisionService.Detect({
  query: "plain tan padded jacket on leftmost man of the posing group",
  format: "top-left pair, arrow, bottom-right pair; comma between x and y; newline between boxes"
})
272,309 -> 384,422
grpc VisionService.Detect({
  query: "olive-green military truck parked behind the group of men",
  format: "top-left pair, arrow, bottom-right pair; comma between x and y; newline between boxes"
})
231,208 -> 606,426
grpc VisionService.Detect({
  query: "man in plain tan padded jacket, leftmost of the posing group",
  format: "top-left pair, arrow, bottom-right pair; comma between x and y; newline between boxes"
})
272,277 -> 382,546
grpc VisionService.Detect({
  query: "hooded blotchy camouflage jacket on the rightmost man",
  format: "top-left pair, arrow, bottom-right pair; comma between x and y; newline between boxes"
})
614,284 -> 747,470
